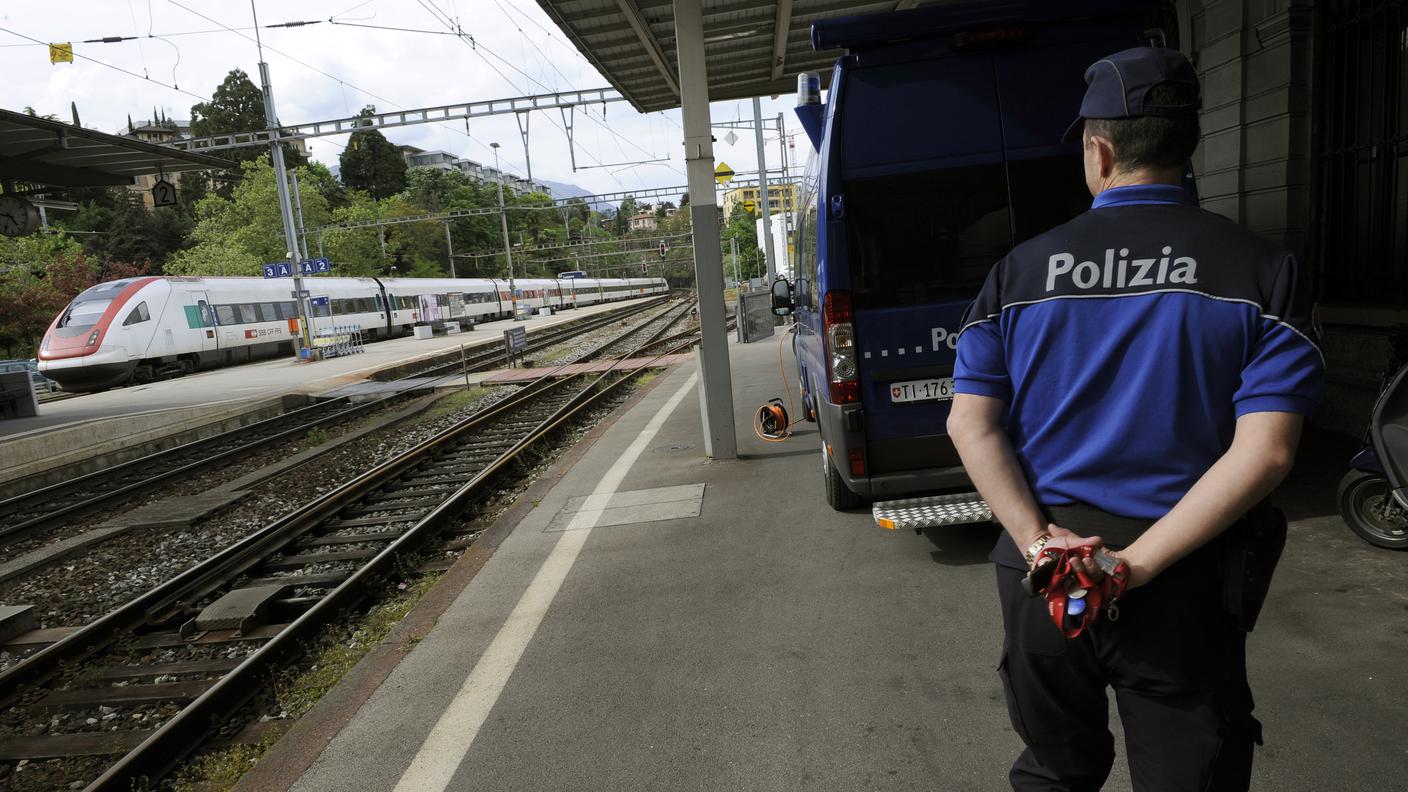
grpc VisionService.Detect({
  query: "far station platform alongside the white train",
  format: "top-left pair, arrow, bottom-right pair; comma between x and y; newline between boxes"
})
0,302 -> 656,483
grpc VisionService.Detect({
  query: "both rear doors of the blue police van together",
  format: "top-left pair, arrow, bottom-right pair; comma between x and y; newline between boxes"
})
845,23 -> 1139,475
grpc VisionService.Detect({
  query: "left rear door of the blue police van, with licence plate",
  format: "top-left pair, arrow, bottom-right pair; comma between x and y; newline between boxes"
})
843,55 -> 1012,475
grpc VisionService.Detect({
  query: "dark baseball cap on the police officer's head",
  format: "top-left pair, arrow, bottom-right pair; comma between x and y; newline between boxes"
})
1060,47 -> 1200,142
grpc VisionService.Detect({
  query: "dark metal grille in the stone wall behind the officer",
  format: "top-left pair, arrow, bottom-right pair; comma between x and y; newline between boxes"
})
1318,0 -> 1408,306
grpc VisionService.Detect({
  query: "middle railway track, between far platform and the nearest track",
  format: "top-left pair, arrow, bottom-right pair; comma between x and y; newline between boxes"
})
0,293 -> 663,558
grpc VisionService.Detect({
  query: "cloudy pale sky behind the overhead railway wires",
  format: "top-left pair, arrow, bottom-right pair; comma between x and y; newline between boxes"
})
0,0 -> 807,193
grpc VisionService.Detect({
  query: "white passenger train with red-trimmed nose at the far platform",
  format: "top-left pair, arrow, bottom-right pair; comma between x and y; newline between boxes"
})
38,278 -> 669,392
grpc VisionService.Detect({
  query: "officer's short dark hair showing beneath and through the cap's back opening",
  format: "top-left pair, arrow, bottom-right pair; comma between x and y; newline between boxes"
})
1086,82 -> 1202,172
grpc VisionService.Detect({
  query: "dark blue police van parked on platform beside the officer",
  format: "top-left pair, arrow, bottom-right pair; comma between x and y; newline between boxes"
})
773,0 -> 1177,509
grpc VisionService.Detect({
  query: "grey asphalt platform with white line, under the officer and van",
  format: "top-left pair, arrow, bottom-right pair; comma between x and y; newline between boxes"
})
237,329 -> 1408,792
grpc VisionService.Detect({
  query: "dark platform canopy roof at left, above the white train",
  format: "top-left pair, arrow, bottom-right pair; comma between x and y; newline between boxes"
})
0,110 -> 230,189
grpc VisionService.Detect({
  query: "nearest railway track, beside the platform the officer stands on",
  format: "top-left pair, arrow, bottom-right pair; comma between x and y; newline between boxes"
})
0,298 -> 691,792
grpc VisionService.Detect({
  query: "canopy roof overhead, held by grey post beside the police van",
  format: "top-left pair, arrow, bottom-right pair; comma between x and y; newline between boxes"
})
538,0 -> 922,113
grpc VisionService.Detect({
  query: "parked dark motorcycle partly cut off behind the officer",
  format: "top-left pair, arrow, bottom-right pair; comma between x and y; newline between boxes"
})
1339,328 -> 1408,550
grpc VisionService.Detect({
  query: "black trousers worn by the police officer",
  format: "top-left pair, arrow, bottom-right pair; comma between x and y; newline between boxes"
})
997,543 -> 1262,792
